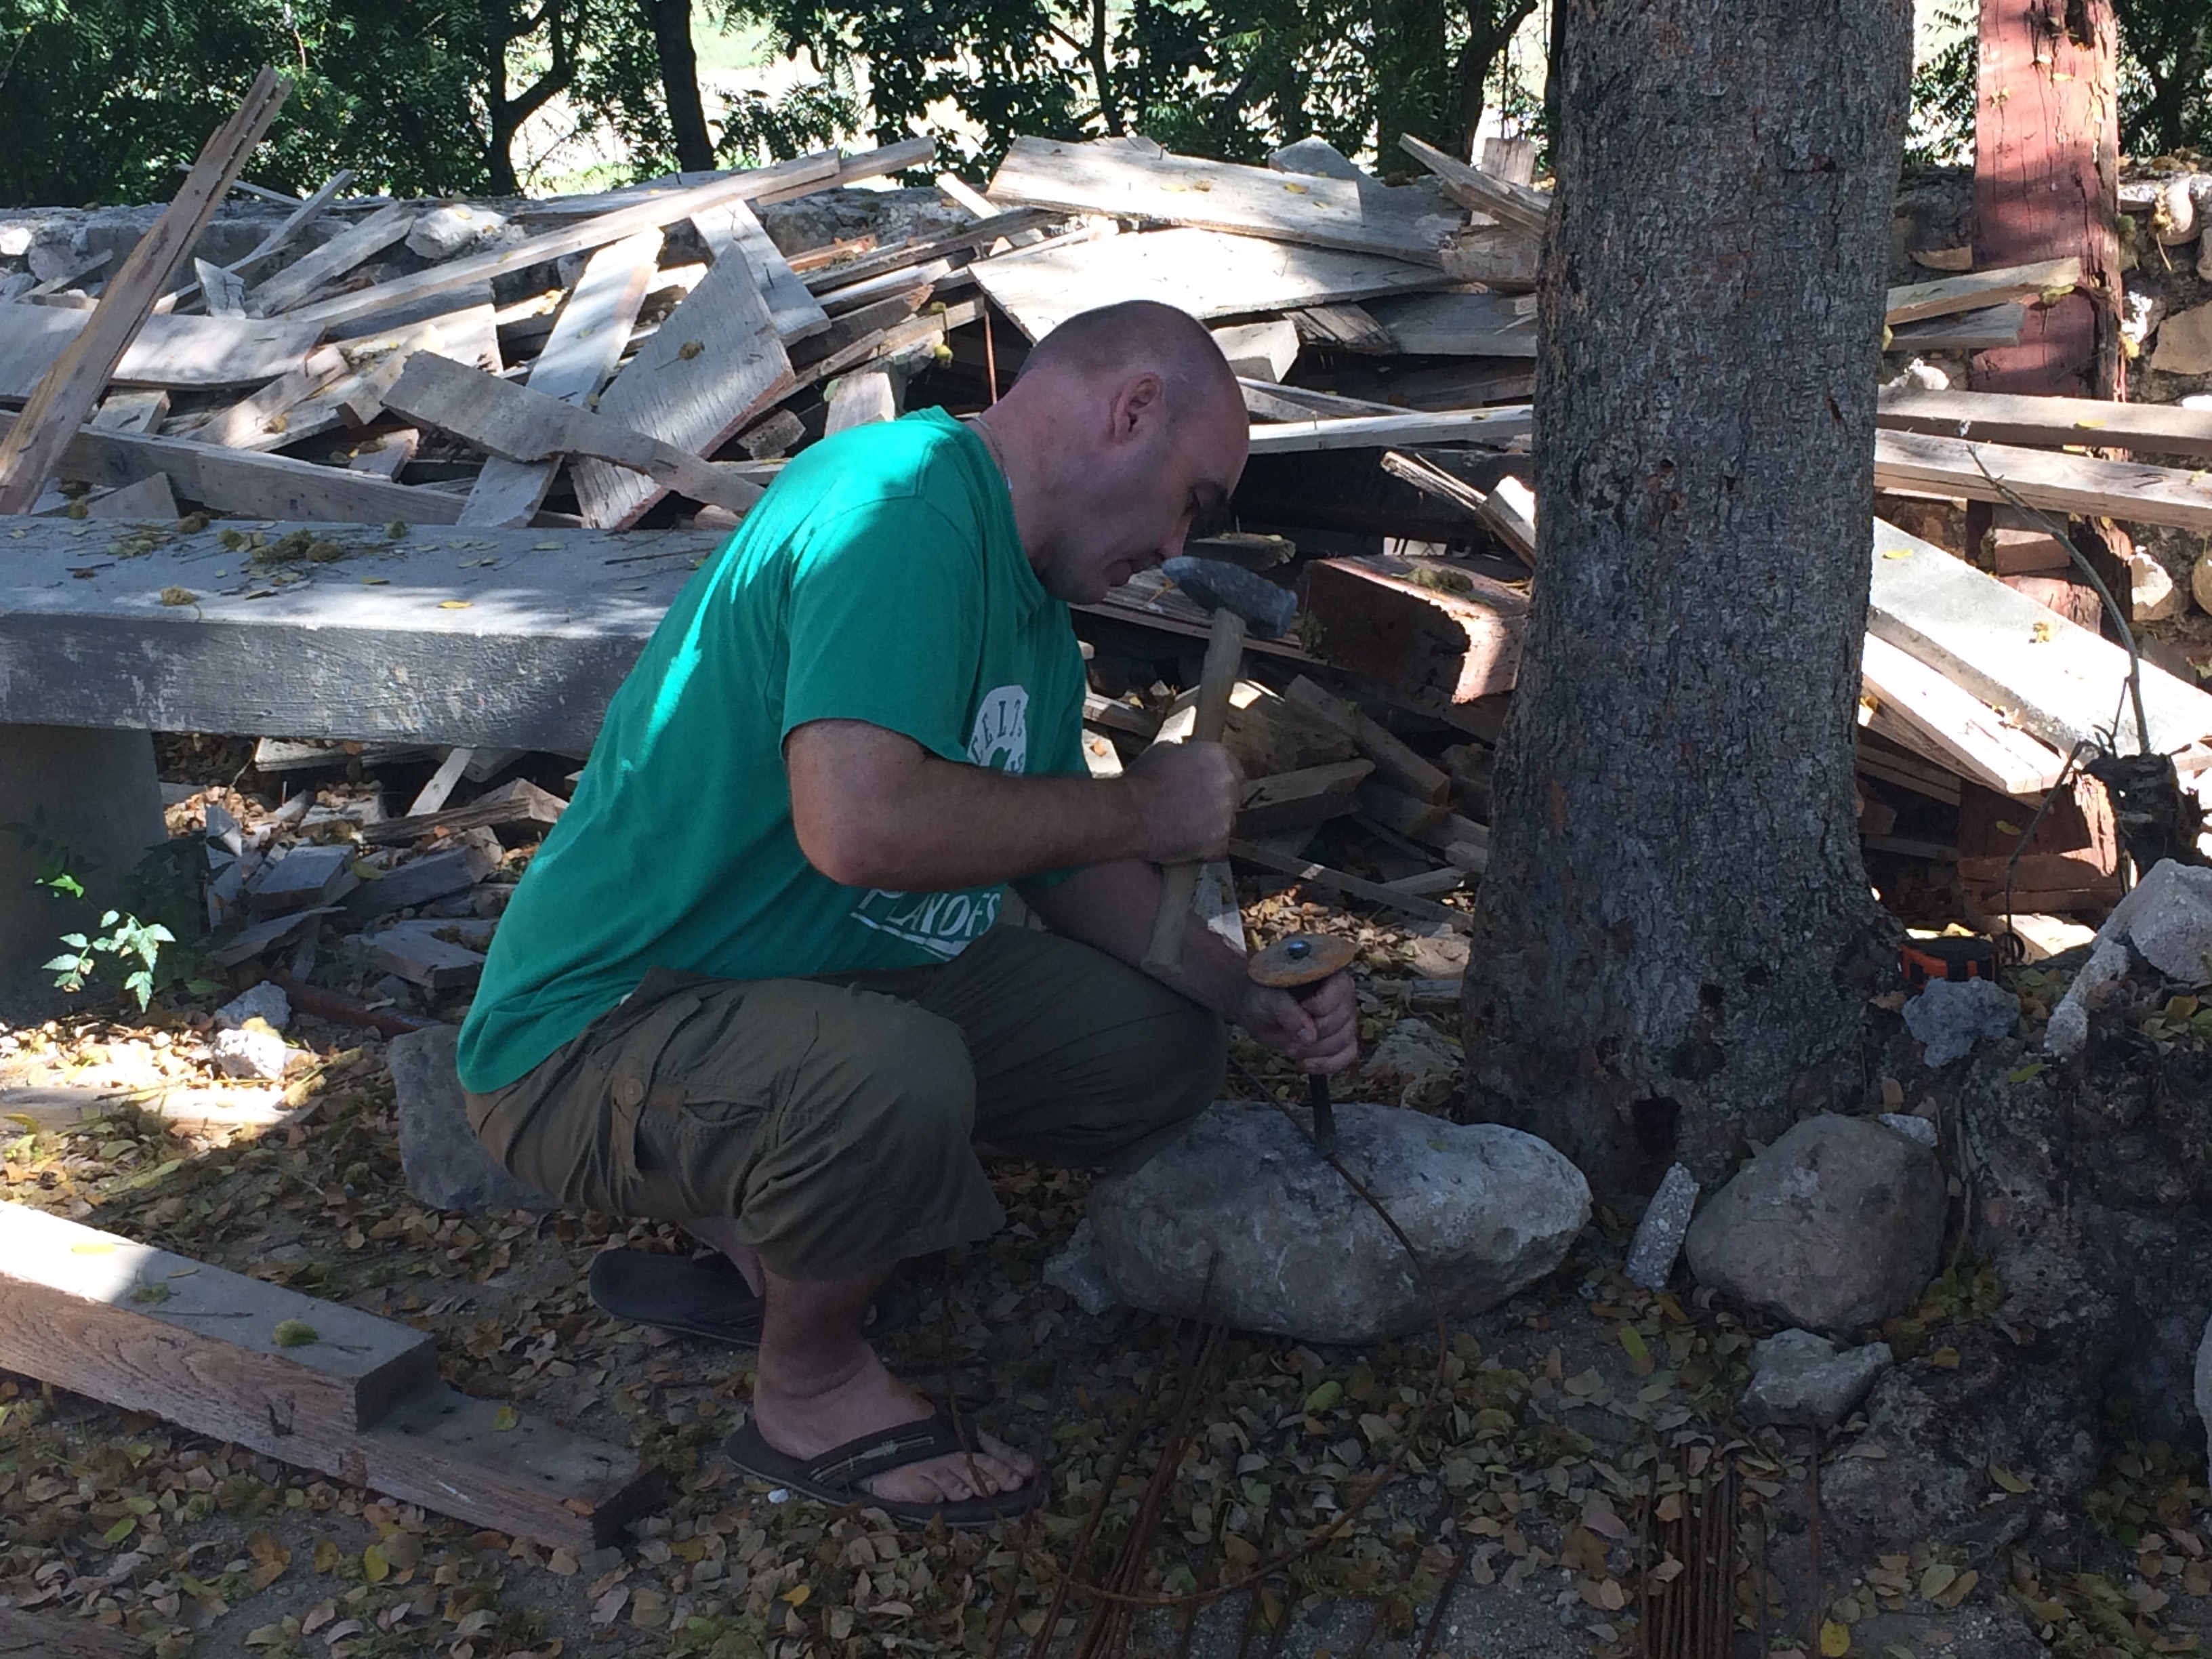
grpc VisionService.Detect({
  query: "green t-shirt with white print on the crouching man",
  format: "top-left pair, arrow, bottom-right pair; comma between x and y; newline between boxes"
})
460,411 -> 1084,1092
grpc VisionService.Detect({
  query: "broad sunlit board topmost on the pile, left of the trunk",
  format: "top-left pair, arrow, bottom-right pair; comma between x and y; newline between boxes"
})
991,137 -> 1460,266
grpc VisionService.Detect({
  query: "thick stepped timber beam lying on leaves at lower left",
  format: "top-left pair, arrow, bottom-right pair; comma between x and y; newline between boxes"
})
0,1204 -> 657,1549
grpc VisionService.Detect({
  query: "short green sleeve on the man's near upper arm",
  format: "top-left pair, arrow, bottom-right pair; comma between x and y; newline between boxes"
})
783,497 -> 982,761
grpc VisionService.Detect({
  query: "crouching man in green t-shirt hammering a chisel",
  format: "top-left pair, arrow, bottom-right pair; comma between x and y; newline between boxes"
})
460,303 -> 1356,1524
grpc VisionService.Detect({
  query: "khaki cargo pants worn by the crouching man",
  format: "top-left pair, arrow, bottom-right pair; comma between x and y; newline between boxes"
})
469,927 -> 1228,1279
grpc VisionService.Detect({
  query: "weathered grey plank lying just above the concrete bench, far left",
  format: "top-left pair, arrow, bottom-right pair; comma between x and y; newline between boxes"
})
0,411 -> 462,522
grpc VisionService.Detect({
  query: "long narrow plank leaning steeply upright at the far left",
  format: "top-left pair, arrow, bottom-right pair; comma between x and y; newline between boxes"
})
0,68 -> 292,513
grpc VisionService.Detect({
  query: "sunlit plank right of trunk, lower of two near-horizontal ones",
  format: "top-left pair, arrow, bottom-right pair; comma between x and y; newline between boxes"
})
1874,431 -> 2212,531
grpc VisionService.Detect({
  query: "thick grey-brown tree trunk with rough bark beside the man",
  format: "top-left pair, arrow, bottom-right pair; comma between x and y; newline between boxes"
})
1465,0 -> 1911,1192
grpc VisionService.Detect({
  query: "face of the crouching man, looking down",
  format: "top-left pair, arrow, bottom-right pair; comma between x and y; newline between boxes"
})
1042,378 -> 1248,604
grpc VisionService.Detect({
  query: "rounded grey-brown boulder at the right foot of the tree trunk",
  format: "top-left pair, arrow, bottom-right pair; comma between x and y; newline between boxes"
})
1687,1113 -> 1944,1332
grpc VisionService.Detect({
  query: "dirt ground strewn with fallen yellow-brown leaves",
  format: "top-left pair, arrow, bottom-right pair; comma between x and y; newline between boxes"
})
0,765 -> 2212,1659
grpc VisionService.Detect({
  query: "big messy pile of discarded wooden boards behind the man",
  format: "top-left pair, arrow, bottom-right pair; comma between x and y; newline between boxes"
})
0,123 -> 2212,946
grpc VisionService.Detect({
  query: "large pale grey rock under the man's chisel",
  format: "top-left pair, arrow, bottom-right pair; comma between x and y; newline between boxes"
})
1090,1101 -> 1591,1343
